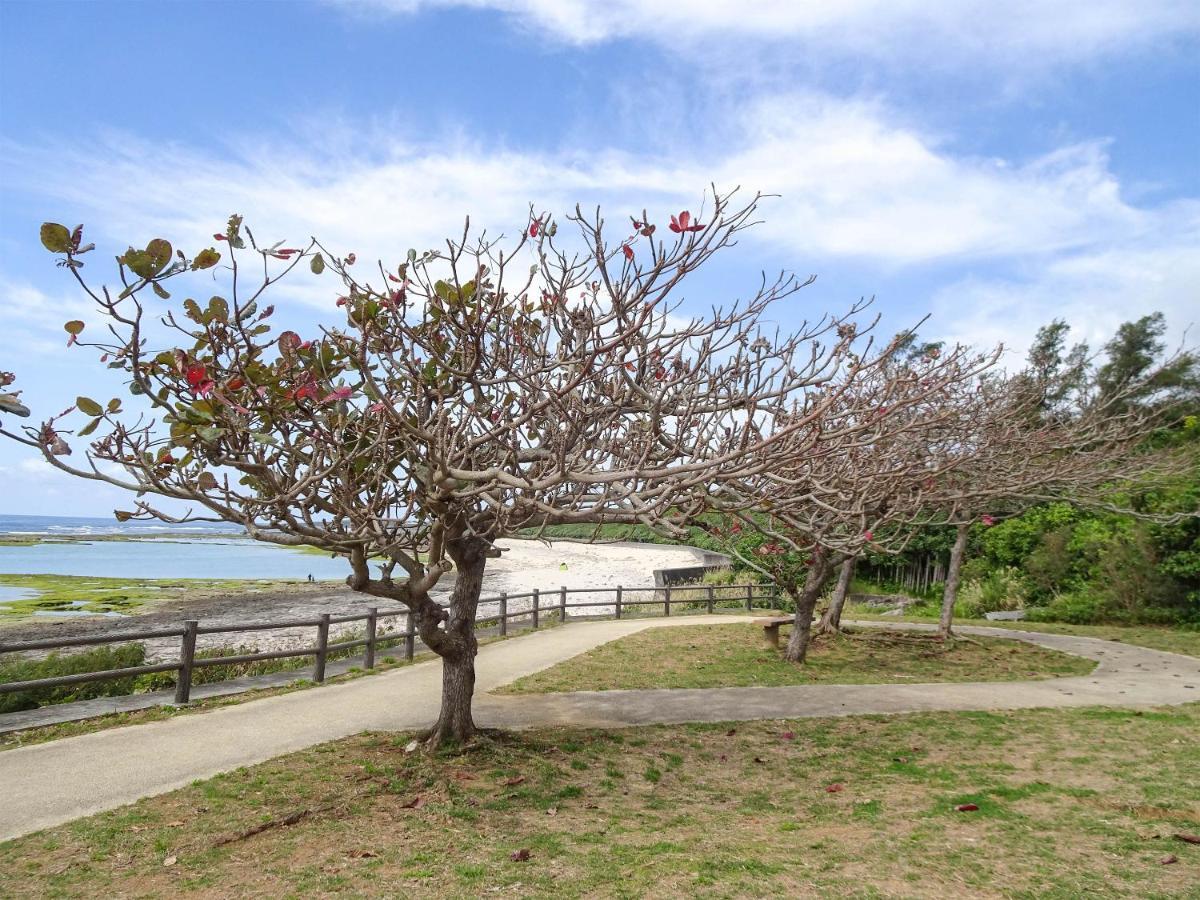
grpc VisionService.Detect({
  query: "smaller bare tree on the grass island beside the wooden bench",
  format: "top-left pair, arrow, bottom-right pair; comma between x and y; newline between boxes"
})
705,335 -> 998,662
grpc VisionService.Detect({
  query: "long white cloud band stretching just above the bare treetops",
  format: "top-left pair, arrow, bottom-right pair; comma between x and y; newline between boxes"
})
0,95 -> 1176,274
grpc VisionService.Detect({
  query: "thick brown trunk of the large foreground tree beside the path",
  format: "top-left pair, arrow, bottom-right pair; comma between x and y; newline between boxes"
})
422,539 -> 487,750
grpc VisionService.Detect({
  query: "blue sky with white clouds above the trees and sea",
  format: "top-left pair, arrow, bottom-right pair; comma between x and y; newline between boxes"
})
0,0 -> 1200,515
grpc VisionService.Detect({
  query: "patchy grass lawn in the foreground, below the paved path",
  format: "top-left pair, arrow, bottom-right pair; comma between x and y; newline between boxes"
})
0,704 -> 1200,898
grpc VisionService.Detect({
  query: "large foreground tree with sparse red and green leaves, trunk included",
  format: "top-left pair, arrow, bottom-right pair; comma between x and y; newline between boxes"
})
0,194 -> 892,745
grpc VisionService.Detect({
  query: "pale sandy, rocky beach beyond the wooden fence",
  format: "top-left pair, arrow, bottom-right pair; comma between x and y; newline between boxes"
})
2,540 -> 703,660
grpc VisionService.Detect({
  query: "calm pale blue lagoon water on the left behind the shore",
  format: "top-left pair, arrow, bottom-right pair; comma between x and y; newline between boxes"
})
0,538 -> 349,580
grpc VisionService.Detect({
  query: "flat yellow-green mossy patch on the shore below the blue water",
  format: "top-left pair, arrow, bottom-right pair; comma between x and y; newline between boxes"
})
0,575 -> 298,623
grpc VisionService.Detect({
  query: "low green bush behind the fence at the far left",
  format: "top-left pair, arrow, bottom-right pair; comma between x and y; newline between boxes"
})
0,643 -> 146,713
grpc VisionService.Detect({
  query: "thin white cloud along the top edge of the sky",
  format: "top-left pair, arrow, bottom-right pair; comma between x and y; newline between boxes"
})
330,0 -> 1200,66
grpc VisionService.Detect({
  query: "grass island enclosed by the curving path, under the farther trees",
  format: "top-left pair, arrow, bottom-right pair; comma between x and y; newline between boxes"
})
502,624 -> 1096,694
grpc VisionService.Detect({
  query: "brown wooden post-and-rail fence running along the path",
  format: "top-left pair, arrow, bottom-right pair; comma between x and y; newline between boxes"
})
0,584 -> 779,704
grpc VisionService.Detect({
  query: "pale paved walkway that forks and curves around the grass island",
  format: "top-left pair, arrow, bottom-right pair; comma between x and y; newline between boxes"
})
0,616 -> 1200,840
